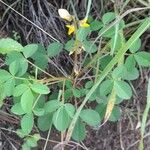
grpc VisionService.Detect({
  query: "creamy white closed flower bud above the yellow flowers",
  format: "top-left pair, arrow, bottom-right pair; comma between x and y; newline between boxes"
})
58,9 -> 73,22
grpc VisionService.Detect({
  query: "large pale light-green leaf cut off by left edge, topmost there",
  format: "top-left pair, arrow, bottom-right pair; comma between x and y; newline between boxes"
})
0,38 -> 23,54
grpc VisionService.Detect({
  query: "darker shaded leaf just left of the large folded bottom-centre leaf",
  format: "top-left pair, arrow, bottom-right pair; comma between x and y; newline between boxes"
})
37,114 -> 53,131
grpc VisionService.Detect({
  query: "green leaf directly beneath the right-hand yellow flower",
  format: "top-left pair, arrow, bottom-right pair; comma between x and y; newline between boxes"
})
76,27 -> 91,42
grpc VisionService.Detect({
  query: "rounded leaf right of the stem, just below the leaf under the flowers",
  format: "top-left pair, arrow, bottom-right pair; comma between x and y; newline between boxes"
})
83,41 -> 97,53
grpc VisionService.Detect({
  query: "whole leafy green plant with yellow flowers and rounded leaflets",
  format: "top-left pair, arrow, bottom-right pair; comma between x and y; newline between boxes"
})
0,4 -> 150,149
